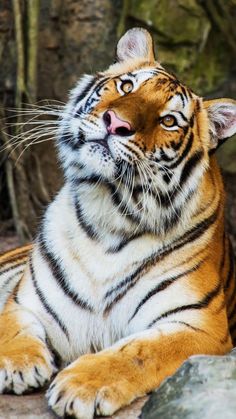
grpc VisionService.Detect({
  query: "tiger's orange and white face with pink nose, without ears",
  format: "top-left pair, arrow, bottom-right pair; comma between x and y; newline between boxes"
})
59,50 -> 208,180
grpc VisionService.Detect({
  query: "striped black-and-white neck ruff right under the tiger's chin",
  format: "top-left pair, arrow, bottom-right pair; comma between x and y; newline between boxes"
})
68,167 -> 212,253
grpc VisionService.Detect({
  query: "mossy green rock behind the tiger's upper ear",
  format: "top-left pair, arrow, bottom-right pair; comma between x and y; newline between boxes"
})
126,0 -> 231,95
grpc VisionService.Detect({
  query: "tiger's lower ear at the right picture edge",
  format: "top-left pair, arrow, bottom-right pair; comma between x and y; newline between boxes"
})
203,99 -> 236,149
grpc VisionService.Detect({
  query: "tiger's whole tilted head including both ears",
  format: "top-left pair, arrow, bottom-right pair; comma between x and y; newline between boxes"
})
59,28 -> 236,240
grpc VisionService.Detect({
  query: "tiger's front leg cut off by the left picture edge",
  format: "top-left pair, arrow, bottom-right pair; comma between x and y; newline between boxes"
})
0,300 -> 56,394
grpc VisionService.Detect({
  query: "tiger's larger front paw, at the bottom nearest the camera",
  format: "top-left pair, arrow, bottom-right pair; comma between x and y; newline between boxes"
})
47,354 -> 142,419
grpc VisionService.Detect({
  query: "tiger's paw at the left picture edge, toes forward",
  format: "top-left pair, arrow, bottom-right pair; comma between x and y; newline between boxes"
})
0,342 -> 57,395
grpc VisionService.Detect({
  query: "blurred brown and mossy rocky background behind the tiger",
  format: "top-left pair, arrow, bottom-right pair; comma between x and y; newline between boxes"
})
0,0 -> 236,250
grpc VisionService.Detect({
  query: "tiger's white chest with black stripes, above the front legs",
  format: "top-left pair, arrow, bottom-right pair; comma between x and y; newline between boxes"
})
15,187 -> 199,362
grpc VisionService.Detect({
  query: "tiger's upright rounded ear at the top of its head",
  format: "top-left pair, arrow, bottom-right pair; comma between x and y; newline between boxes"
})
116,28 -> 155,62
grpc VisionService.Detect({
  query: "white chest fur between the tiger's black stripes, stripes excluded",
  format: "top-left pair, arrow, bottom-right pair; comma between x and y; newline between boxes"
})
19,180 -> 208,363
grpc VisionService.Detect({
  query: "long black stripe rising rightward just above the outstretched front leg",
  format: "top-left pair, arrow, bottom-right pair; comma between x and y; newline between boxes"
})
148,282 -> 222,328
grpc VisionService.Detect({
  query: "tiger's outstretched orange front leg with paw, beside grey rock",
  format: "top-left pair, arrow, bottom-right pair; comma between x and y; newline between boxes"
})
47,324 -> 231,419
